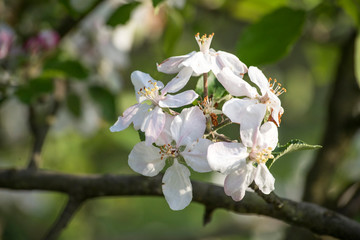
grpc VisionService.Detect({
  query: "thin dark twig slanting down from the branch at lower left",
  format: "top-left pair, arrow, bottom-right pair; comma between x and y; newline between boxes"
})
44,196 -> 83,240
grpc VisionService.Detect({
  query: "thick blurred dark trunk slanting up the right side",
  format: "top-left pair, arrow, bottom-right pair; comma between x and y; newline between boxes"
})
304,32 -> 360,205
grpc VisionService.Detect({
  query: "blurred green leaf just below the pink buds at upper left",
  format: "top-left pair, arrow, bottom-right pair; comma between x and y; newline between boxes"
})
42,59 -> 88,80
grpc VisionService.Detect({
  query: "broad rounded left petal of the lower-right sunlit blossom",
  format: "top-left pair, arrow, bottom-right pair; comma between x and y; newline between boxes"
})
207,142 -> 249,173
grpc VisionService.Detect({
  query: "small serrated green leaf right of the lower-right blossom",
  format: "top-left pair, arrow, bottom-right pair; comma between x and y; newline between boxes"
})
266,139 -> 322,168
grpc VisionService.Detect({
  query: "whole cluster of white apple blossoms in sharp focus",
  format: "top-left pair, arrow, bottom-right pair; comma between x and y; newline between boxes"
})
110,34 -> 286,210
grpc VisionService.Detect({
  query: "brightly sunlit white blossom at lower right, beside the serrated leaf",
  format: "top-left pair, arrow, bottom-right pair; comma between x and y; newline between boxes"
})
207,122 -> 278,201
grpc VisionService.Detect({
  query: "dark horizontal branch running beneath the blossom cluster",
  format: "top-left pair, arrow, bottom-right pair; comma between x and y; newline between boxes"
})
0,169 -> 360,240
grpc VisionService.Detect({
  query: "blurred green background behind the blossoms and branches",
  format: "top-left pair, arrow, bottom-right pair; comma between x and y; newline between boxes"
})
0,0 -> 360,240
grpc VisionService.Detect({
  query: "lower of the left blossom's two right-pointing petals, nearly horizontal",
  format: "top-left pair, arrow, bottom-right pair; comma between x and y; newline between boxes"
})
159,90 -> 199,108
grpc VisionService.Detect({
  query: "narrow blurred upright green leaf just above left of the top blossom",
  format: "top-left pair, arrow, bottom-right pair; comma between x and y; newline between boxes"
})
163,9 -> 184,56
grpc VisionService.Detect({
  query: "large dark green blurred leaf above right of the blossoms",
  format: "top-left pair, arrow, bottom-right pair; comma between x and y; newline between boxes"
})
237,7 -> 305,66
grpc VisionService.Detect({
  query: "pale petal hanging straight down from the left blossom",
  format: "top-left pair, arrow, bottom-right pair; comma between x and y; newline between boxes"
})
141,107 -> 165,145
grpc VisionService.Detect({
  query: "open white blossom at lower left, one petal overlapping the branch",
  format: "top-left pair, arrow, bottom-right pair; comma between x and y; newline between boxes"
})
129,107 -> 211,210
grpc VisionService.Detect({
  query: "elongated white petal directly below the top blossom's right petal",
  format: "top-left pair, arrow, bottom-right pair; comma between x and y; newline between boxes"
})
216,67 -> 257,98
